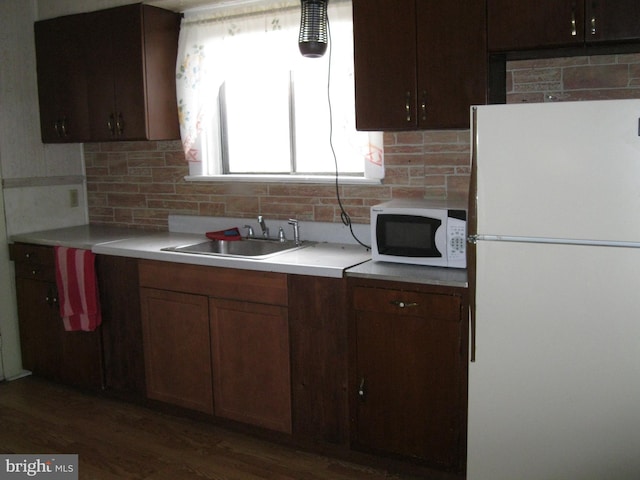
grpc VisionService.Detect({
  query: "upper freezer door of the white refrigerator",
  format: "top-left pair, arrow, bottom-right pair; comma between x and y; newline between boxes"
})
473,100 -> 640,242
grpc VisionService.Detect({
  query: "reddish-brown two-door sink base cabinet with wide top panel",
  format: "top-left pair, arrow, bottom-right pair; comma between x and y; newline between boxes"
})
139,260 -> 291,433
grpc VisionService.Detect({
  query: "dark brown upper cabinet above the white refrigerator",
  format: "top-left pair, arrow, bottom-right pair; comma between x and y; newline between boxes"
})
487,0 -> 640,52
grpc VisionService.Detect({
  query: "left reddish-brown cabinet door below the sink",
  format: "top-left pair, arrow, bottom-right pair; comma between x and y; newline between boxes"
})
140,288 -> 213,413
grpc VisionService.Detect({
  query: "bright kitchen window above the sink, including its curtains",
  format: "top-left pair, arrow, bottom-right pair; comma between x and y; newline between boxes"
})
176,0 -> 384,180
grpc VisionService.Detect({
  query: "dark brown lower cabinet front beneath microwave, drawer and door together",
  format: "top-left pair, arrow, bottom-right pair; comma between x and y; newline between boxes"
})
354,288 -> 466,469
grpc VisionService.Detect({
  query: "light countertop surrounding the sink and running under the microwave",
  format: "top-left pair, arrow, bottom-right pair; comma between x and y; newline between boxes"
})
11,225 -> 467,288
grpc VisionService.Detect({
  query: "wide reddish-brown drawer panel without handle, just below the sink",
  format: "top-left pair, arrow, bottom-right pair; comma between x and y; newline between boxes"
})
139,260 -> 288,306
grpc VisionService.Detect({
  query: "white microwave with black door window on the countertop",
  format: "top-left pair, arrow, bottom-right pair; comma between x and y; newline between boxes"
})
371,200 -> 467,268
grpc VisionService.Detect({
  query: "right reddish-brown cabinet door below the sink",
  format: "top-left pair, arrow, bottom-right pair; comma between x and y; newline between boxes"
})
210,299 -> 291,433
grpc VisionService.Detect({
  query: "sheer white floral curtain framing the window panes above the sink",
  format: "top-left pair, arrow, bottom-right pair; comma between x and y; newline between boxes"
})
176,0 -> 384,179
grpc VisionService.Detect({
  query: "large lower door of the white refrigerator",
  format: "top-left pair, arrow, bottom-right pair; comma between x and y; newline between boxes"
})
467,241 -> 640,480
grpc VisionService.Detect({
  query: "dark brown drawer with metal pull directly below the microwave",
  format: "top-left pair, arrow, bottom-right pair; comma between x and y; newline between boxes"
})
353,287 -> 461,321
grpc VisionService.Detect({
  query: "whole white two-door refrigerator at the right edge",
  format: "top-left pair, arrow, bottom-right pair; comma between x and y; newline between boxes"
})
467,100 -> 640,480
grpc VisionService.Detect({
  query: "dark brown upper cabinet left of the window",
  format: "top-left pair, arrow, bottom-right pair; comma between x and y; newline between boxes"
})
35,4 -> 180,143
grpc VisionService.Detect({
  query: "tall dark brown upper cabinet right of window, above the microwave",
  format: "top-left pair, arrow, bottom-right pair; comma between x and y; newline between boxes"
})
353,0 -> 487,130
